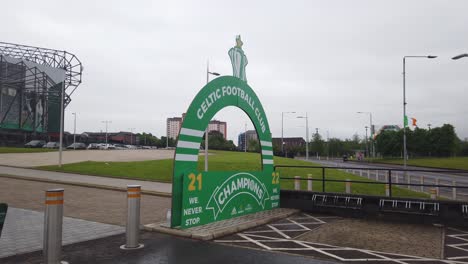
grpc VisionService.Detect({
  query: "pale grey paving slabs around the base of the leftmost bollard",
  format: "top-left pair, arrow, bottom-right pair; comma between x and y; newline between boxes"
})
0,207 -> 125,258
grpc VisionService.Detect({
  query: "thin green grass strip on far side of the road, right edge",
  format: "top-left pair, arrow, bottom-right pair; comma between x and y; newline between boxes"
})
373,157 -> 468,170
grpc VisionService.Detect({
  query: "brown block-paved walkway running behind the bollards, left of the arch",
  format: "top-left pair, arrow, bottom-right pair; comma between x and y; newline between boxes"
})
0,177 -> 171,226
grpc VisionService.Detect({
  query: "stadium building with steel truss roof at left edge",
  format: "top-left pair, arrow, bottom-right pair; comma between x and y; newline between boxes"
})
0,42 -> 83,146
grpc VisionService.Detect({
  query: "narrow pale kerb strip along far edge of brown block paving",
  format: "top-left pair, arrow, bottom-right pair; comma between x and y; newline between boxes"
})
0,174 -> 172,197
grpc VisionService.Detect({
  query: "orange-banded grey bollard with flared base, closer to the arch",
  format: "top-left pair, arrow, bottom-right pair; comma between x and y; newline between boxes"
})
120,185 -> 143,249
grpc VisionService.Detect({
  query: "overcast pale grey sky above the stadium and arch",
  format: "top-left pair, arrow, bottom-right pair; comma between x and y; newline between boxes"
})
0,0 -> 468,144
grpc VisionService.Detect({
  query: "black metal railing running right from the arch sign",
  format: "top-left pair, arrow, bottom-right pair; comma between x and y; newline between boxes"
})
274,165 -> 468,197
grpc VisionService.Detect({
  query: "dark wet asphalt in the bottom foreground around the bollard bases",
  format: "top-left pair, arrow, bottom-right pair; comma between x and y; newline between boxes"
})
0,232 -> 334,264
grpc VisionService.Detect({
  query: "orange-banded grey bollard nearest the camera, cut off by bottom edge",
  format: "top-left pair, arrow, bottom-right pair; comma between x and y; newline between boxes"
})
43,189 -> 67,264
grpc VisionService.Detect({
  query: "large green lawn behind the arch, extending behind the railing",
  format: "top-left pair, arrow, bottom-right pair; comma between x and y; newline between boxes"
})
39,151 -> 429,198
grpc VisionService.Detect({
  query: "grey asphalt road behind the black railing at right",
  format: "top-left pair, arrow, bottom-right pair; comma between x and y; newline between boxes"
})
298,159 -> 468,201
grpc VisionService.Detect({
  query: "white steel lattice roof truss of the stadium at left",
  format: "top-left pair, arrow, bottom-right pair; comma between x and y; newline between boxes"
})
0,42 -> 83,106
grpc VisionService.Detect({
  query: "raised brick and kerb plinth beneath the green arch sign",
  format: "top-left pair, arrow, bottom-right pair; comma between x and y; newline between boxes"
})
144,209 -> 299,241
